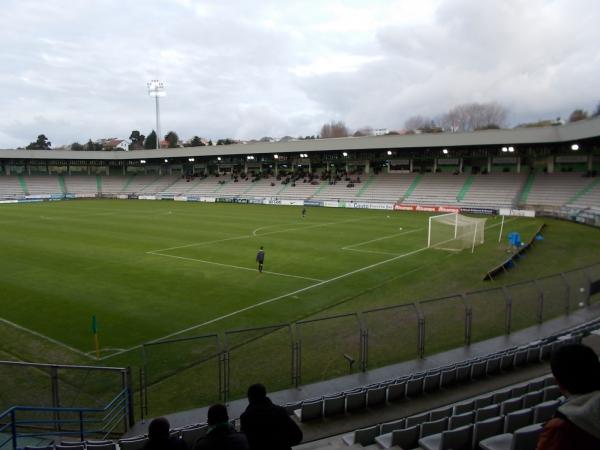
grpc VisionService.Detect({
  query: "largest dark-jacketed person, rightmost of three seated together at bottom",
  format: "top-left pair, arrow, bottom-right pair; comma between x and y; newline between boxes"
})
240,384 -> 302,450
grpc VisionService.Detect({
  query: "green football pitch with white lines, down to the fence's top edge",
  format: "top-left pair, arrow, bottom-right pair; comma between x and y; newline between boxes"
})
0,200 -> 600,410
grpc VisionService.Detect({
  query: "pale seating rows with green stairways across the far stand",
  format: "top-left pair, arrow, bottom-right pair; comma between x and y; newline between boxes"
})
0,173 -> 600,210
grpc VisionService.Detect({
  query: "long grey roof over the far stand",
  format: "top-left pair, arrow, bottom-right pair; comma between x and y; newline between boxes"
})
0,118 -> 600,160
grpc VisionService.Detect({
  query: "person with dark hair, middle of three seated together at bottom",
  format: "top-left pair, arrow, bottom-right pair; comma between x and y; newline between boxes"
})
194,404 -> 249,450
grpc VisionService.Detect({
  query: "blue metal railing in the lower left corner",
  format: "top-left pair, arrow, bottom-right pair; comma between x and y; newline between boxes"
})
0,387 -> 133,450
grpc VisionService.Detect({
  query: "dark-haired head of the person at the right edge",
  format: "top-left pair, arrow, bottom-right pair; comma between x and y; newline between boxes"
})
550,344 -> 600,395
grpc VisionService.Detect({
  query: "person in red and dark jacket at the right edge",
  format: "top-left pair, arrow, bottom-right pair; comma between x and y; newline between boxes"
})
537,344 -> 600,450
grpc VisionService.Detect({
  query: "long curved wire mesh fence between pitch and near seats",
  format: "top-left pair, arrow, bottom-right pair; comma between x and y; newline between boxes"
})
140,263 -> 600,417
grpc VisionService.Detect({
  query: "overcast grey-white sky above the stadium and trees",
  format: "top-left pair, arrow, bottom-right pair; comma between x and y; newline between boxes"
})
0,0 -> 600,148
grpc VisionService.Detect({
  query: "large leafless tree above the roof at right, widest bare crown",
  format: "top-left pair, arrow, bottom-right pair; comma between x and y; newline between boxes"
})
440,102 -> 508,131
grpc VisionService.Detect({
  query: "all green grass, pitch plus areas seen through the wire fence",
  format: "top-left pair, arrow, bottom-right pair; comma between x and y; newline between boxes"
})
0,200 -> 600,414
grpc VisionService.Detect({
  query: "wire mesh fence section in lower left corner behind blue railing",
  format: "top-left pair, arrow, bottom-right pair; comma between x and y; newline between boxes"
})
0,361 -> 134,448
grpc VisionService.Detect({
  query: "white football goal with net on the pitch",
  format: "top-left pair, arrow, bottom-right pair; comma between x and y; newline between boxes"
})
427,213 -> 486,252
